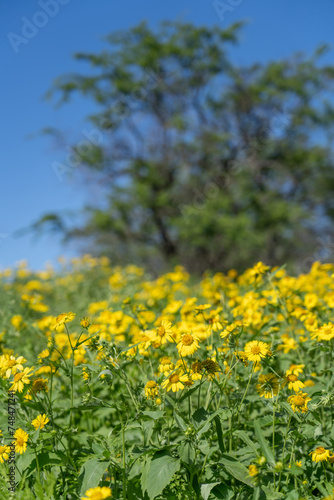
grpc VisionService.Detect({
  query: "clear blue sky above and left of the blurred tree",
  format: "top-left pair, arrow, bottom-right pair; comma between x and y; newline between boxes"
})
0,0 -> 334,269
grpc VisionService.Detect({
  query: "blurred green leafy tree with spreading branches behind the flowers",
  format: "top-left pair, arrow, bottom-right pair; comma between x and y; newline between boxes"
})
36,23 -> 334,272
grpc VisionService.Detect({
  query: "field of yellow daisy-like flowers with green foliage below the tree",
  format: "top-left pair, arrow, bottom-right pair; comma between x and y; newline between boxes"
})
0,256 -> 334,500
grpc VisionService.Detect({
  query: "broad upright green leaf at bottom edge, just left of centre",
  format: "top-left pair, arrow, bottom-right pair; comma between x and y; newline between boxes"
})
147,451 -> 181,500
